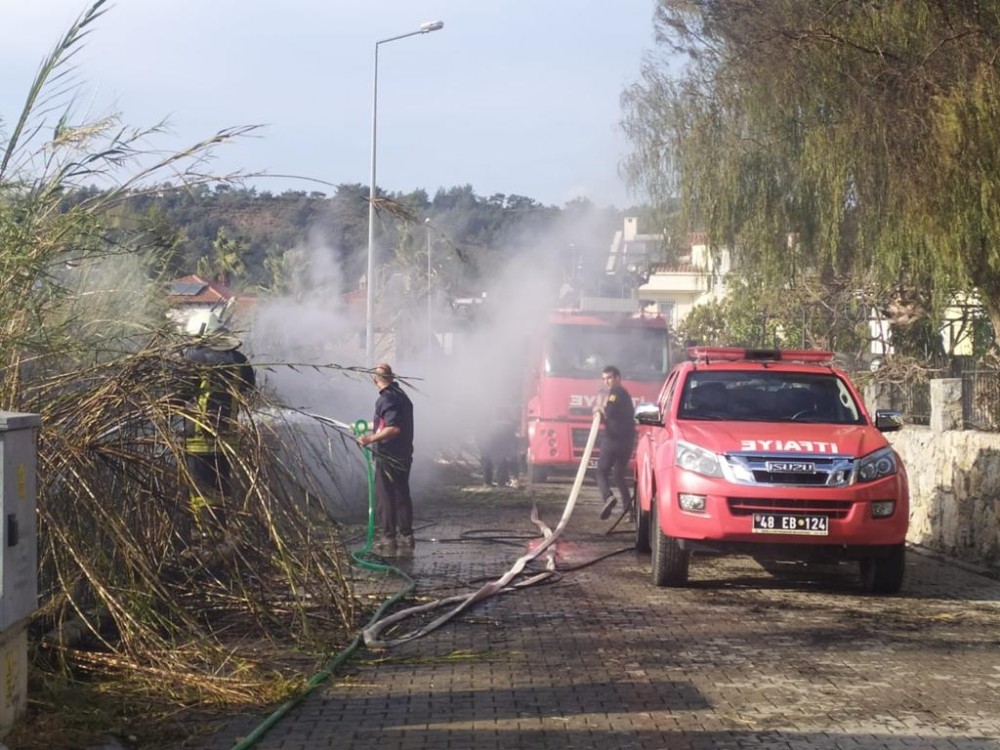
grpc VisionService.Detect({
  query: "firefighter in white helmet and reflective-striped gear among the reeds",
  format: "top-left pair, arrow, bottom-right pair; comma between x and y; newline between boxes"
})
182,311 -> 256,536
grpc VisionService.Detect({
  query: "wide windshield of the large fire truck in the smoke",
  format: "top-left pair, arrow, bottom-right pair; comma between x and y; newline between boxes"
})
545,325 -> 669,382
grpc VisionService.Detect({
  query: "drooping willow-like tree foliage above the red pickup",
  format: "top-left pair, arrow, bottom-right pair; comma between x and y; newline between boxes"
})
623,0 -> 1000,346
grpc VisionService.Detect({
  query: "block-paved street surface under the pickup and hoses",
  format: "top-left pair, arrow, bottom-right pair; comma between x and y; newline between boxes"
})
185,472 -> 1000,750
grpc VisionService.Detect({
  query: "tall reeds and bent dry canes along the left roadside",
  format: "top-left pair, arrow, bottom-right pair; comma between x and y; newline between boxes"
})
0,2 -> 354,746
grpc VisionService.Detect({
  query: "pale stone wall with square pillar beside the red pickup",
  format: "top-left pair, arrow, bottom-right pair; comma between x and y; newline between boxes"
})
865,379 -> 1000,572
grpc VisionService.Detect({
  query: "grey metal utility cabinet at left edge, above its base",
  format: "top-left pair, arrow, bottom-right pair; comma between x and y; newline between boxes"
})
0,411 -> 41,632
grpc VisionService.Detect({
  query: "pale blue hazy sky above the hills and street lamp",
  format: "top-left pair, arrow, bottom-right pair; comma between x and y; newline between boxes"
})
0,0 -> 655,208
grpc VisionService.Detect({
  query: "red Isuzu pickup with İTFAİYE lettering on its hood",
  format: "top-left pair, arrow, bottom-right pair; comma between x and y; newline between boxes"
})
633,347 -> 909,593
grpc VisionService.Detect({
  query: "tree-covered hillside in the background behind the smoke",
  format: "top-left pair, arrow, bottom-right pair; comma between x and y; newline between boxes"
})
97,183 -> 636,306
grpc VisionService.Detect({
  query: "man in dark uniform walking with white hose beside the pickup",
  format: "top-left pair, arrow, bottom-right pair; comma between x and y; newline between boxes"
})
594,365 -> 635,520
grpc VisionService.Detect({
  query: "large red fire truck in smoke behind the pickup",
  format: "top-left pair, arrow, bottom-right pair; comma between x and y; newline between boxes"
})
523,298 -> 670,482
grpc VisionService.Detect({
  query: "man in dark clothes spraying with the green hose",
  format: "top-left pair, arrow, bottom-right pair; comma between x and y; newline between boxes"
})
358,363 -> 413,553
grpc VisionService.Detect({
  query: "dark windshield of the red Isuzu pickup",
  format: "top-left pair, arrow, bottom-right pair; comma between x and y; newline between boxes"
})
677,370 -> 864,424
